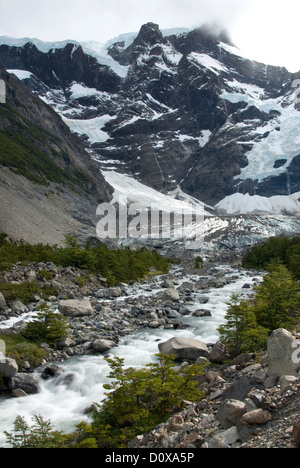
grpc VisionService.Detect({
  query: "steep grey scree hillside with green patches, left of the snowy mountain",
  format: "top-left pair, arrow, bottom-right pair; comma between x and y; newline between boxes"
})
0,69 -> 111,244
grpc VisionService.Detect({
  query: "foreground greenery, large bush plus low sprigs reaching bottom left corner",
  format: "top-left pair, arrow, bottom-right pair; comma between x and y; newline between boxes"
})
5,354 -> 204,448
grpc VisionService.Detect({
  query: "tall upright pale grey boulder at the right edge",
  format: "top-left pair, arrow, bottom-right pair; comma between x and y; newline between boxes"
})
268,328 -> 299,377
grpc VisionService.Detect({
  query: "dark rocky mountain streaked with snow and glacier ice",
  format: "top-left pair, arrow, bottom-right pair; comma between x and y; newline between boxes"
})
0,23 -> 300,249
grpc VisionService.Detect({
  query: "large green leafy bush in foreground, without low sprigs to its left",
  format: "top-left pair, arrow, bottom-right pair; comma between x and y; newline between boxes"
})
87,354 -> 204,448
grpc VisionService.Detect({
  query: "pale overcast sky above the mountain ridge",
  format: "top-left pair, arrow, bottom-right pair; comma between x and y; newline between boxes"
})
0,0 -> 300,72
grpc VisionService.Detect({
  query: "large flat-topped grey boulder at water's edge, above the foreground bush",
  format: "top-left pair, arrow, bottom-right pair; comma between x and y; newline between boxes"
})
158,338 -> 209,361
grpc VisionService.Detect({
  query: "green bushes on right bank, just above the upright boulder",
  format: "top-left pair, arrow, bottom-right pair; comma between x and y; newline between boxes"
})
218,249 -> 300,355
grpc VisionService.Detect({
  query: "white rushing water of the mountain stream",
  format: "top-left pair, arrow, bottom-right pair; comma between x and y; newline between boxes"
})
0,270 -> 260,446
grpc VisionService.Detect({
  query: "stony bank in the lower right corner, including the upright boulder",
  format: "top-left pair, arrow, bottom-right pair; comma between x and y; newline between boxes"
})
130,329 -> 300,449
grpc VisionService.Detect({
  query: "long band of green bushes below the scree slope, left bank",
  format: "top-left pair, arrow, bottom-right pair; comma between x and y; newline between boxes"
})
0,233 -> 169,287
